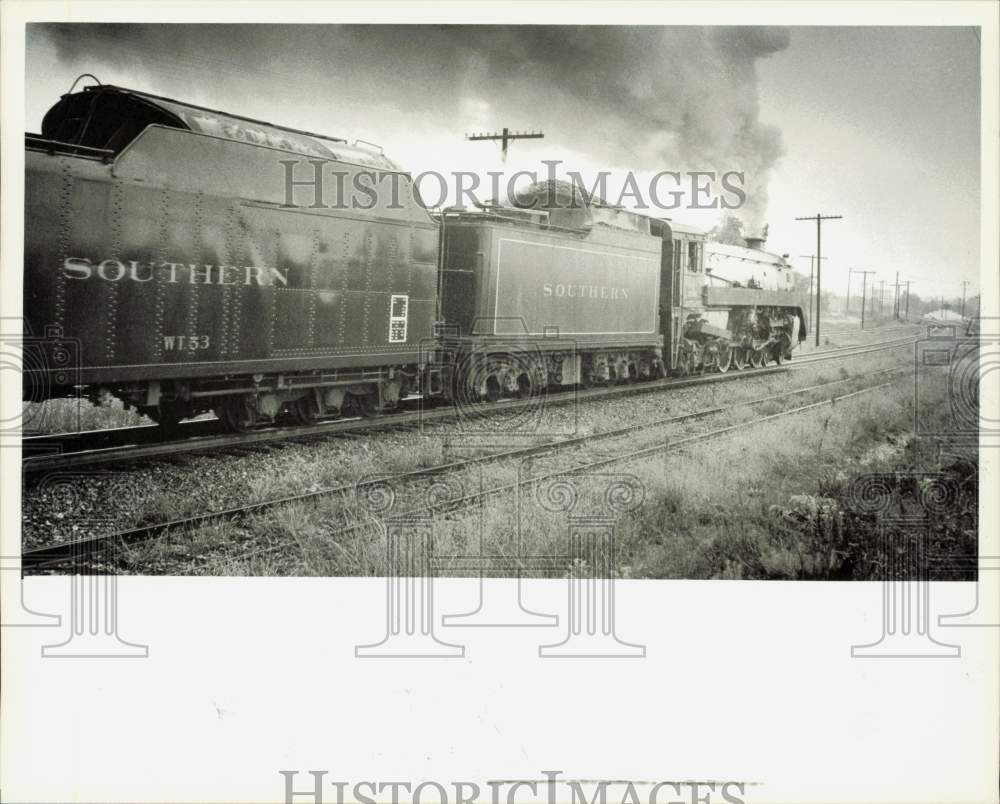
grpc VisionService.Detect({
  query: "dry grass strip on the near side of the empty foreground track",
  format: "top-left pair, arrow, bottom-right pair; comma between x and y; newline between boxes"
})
176,362 -> 961,579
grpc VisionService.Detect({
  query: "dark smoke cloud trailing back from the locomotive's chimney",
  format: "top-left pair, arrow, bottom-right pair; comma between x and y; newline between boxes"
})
42,25 -> 789,229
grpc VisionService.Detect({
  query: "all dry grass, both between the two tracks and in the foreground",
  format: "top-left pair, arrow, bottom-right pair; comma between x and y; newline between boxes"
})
113,332 -> 974,578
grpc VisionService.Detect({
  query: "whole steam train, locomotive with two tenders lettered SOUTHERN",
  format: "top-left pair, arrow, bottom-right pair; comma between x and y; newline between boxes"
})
23,85 -> 808,430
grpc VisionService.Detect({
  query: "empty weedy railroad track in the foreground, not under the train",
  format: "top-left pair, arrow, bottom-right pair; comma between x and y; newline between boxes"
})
21,368 -> 906,571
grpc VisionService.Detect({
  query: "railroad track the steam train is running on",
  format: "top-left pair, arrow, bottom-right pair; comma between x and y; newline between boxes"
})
21,335 -> 917,476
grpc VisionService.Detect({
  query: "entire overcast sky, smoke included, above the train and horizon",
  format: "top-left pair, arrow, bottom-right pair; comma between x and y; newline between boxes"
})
26,24 -> 980,296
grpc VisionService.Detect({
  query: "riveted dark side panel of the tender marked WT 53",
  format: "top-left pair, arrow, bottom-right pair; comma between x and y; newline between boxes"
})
25,127 -> 438,382
